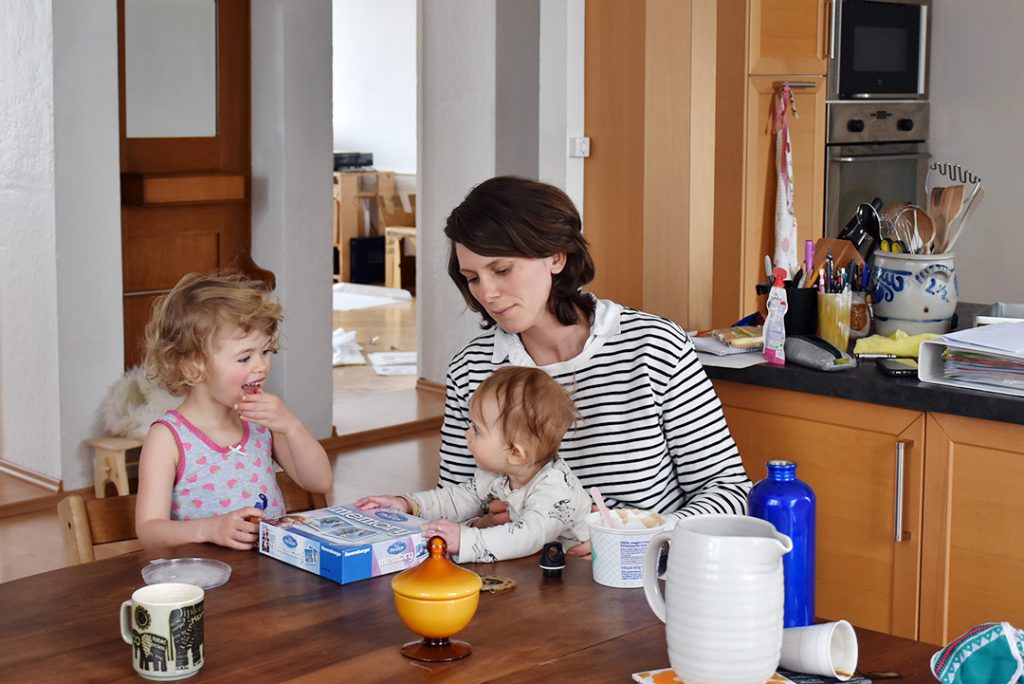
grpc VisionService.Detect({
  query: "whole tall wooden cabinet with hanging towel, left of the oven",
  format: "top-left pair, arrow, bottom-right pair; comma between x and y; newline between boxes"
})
712,0 -> 829,326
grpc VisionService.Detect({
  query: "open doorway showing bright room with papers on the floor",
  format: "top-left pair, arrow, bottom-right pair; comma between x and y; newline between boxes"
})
332,0 -> 418,434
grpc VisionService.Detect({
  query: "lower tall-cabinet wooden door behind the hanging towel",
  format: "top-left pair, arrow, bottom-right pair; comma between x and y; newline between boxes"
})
730,76 -> 825,323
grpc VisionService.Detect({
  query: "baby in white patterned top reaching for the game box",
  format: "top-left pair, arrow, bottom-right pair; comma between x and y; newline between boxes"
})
356,367 -> 590,563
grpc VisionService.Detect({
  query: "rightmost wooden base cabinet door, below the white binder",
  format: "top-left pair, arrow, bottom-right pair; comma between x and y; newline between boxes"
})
921,414 -> 1024,644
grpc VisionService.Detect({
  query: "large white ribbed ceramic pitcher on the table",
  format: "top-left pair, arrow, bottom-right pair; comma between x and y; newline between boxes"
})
643,515 -> 793,684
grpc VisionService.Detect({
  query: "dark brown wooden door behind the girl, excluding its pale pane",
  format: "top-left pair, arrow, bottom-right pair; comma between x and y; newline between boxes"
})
118,0 -> 272,368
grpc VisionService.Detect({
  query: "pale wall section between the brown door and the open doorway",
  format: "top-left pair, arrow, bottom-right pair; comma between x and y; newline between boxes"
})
252,0 -> 334,438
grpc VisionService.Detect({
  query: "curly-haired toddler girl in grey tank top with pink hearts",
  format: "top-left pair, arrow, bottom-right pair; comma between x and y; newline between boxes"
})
135,273 -> 332,549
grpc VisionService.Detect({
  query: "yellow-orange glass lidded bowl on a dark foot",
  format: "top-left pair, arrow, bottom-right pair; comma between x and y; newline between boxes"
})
391,537 -> 483,662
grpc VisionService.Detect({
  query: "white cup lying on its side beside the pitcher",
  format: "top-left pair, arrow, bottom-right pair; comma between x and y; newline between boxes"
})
778,619 -> 857,681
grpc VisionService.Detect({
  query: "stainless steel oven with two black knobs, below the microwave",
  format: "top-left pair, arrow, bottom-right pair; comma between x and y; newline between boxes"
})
824,101 -> 930,238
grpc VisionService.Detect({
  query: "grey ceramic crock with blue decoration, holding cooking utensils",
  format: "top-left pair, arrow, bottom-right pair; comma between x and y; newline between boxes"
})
871,252 -> 959,335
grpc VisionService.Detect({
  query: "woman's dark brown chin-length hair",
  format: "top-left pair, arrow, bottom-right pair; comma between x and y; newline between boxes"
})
444,176 -> 594,328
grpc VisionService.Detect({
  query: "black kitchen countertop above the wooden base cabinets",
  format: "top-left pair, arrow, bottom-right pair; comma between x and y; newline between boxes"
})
705,304 -> 1024,425
